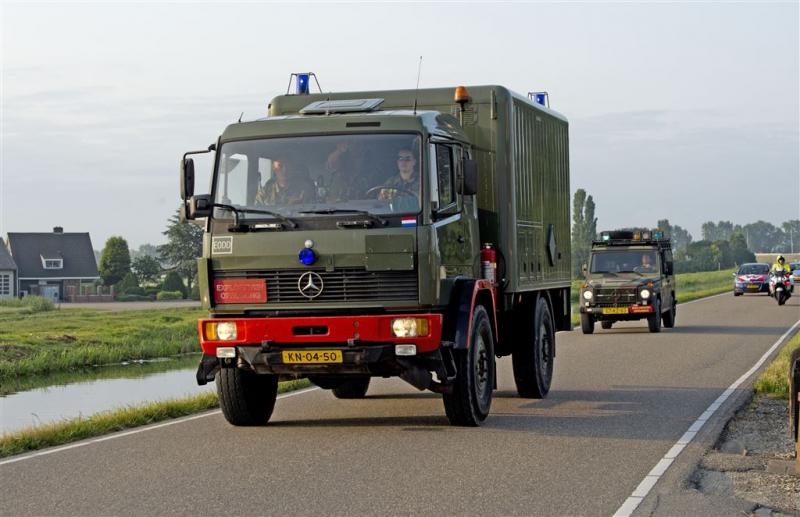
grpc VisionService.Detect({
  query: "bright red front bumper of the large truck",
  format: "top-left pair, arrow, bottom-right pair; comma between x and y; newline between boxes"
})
197,314 -> 442,356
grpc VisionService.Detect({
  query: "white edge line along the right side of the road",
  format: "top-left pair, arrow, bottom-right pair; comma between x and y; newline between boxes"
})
614,316 -> 800,517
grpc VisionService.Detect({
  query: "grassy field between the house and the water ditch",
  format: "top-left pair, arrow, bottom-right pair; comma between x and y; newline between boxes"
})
0,307 -> 206,378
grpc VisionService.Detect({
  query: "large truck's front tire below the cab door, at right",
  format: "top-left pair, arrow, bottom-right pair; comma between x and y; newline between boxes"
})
442,305 -> 495,427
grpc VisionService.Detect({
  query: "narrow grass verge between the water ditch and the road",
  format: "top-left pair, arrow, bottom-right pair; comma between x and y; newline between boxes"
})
0,379 -> 311,458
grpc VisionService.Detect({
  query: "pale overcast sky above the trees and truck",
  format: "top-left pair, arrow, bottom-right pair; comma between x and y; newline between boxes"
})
0,1 -> 800,249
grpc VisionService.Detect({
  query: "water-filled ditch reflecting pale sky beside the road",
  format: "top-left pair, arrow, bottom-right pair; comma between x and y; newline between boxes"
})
0,355 -> 214,434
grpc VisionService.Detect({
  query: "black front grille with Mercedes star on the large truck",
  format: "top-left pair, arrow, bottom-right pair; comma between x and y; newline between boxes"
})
214,268 -> 418,304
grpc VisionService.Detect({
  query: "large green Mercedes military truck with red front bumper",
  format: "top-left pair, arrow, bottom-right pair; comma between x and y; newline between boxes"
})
181,80 -> 571,426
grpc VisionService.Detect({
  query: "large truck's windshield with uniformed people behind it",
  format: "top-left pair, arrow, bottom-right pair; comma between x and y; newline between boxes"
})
214,133 -> 422,219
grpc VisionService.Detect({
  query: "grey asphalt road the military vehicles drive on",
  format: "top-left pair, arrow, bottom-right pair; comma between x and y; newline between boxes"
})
0,295 -> 800,515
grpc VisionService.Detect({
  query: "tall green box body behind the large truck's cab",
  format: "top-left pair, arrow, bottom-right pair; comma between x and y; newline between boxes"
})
269,86 -> 571,294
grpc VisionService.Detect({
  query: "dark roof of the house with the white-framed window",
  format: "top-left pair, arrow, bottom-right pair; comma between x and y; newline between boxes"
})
8,232 -> 100,278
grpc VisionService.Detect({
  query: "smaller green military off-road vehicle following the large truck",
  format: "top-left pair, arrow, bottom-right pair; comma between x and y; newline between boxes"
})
579,230 -> 677,334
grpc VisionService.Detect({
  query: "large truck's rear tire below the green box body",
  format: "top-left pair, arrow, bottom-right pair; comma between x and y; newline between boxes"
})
512,297 -> 556,399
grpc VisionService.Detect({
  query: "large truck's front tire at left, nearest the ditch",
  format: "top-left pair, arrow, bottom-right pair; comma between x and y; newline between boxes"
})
217,368 -> 278,426
